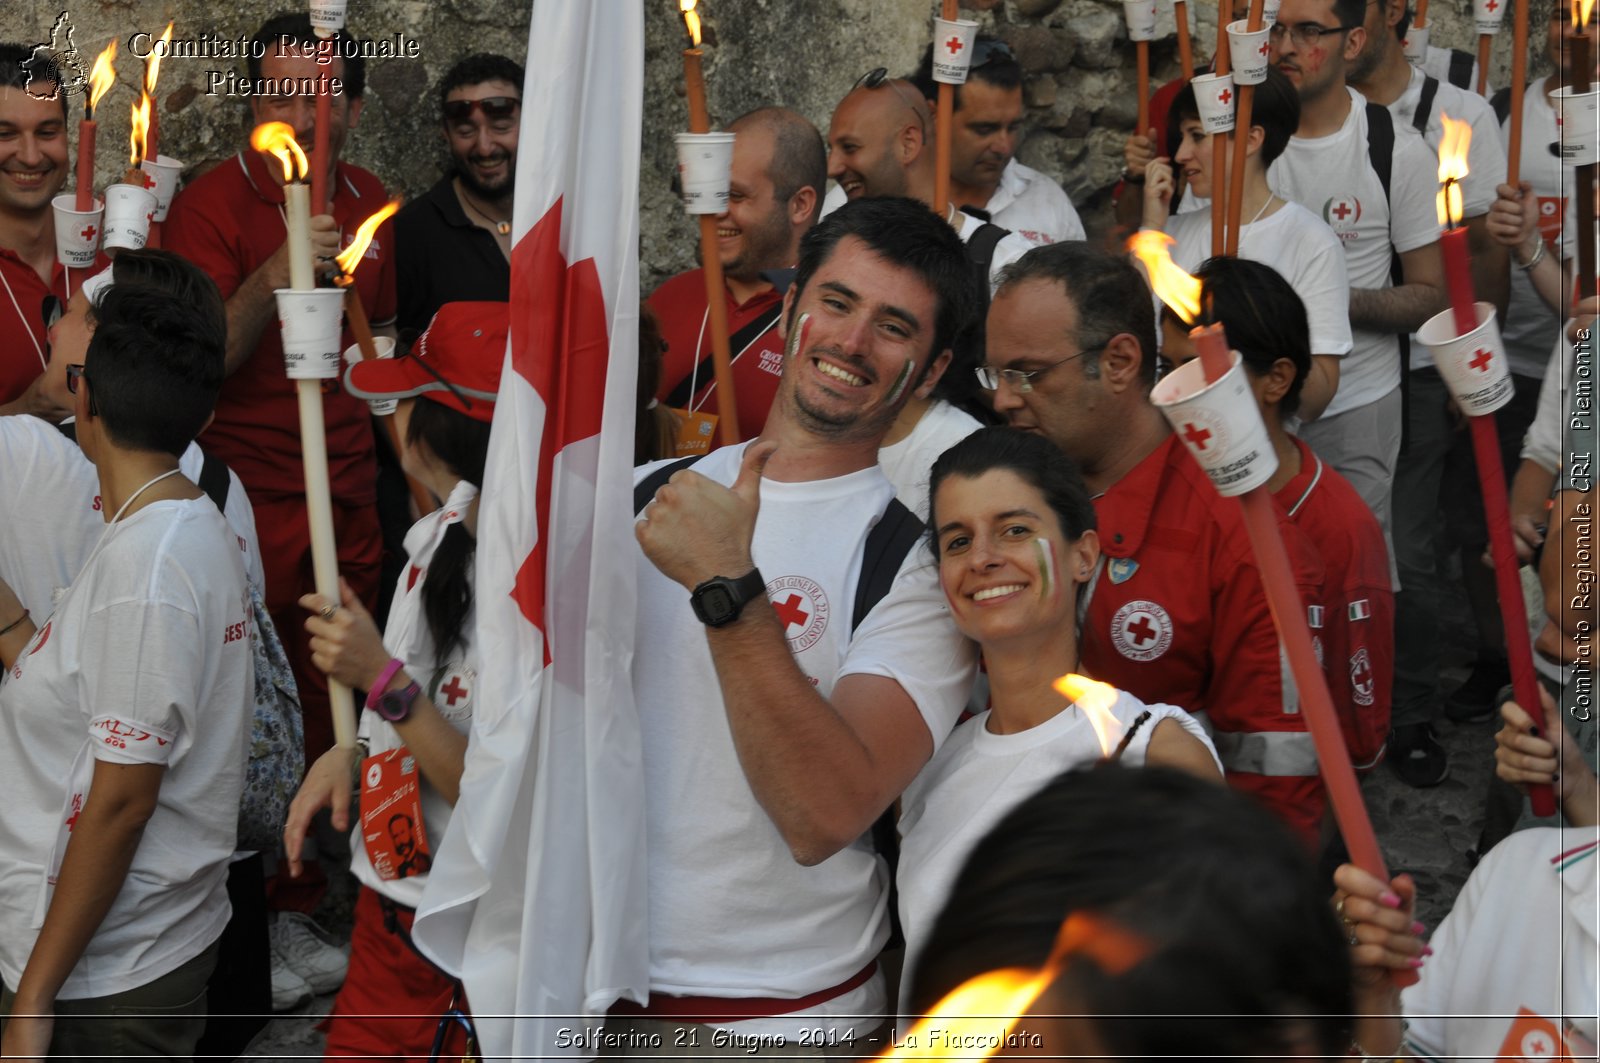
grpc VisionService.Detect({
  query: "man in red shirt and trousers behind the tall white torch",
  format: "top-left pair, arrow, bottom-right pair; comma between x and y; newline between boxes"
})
163,14 -> 395,762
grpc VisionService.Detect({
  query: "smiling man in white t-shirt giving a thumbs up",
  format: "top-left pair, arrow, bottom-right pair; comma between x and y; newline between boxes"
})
620,199 -> 974,1052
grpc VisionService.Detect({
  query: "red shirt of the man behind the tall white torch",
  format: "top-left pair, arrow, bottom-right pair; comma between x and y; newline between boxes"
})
163,150 -> 395,506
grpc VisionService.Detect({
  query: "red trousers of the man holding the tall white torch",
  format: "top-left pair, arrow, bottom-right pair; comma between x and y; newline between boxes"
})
250,498 -> 384,767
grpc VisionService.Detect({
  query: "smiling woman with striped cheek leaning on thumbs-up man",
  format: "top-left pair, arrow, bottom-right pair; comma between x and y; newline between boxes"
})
898,427 -> 1222,1010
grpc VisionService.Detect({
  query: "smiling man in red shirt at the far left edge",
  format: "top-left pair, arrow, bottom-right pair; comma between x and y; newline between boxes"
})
0,43 -> 106,421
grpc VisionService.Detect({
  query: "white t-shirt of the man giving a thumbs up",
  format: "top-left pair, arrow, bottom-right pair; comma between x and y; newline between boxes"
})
634,445 -> 974,1037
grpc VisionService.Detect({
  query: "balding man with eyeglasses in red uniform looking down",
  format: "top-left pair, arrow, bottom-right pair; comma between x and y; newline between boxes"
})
978,243 -> 1323,842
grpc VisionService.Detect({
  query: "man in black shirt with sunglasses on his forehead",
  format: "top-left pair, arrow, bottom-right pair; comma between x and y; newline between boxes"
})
395,53 -> 522,334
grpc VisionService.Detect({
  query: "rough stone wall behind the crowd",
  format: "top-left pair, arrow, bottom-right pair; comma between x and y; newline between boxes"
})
0,0 -> 1547,291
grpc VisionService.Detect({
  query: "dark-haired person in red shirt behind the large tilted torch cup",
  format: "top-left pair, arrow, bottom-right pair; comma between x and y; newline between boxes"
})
1162,258 -> 1395,770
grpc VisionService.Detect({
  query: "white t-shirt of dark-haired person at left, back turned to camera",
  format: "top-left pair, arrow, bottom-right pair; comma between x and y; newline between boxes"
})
0,496 -> 254,1001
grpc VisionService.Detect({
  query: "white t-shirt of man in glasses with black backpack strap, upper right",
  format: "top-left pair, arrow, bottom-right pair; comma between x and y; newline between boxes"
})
1267,88 -> 1438,418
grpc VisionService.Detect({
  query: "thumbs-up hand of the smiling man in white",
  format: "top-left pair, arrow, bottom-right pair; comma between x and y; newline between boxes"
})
634,440 -> 778,591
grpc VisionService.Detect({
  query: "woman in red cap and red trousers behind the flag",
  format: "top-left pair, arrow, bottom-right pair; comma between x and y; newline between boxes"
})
285,303 -> 509,1058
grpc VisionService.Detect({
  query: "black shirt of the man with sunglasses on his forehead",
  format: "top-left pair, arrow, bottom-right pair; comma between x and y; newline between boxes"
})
395,174 -> 510,331
